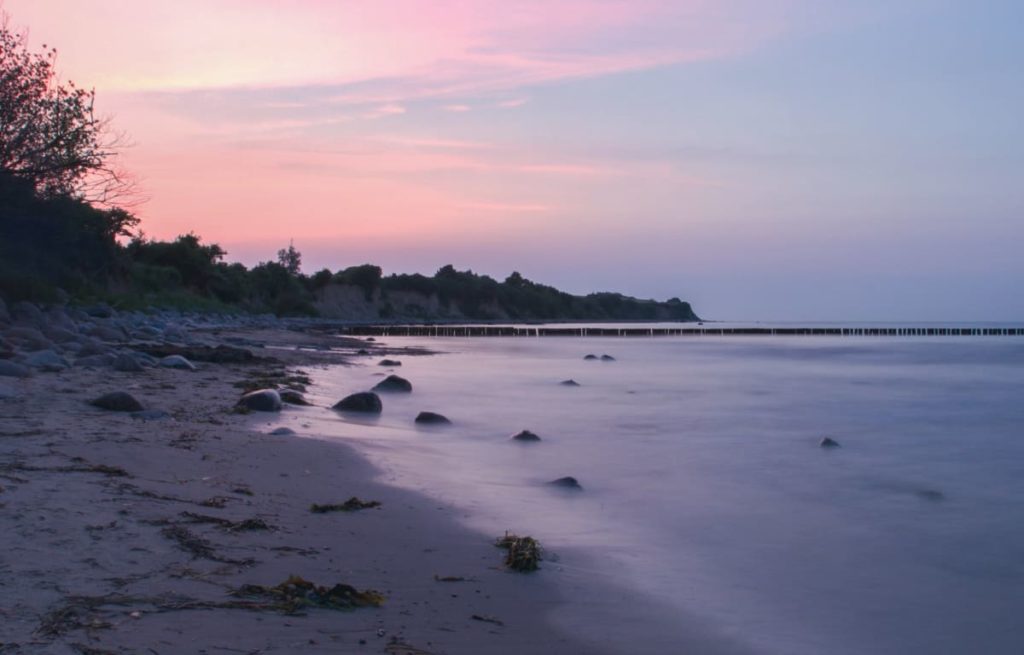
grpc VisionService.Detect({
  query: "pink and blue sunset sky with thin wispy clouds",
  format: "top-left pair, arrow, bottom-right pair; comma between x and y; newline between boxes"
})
0,0 -> 1024,321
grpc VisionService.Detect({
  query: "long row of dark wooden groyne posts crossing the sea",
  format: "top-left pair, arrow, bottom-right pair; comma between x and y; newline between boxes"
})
339,325 -> 1024,337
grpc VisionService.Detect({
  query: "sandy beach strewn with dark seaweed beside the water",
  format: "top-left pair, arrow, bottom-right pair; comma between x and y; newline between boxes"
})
0,323 -> 596,655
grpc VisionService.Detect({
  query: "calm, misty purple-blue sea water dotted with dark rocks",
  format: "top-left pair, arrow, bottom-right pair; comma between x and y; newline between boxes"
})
299,337 -> 1024,654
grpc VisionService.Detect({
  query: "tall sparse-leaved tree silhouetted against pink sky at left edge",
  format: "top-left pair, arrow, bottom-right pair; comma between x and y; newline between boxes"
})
0,11 -> 134,206
